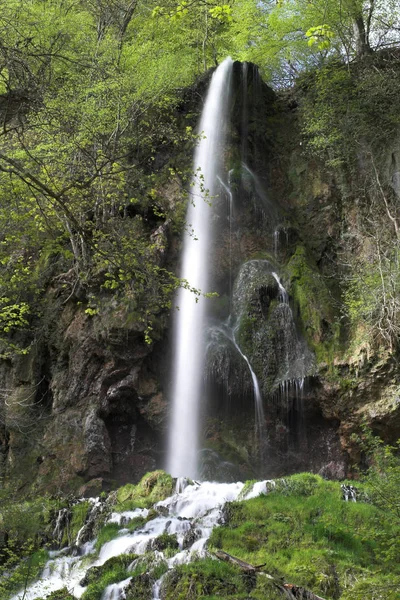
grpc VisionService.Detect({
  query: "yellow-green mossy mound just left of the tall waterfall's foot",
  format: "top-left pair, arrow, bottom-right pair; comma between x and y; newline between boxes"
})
114,471 -> 174,512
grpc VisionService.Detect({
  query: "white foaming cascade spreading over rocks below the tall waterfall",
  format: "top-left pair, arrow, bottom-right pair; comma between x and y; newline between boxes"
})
12,480 -> 275,600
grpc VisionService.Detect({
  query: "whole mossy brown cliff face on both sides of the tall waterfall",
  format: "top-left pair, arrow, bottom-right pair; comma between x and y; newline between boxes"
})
0,63 -> 400,494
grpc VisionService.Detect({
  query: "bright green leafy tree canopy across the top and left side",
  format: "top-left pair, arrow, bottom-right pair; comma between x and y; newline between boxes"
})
0,0 -> 400,354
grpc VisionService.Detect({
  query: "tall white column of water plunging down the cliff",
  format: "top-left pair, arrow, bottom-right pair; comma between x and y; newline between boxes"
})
167,58 -> 233,477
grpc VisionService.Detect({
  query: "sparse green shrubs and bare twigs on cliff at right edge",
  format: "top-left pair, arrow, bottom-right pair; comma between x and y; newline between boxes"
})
300,51 -> 400,349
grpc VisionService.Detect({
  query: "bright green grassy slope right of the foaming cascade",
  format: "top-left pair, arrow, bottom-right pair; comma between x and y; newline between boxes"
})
209,474 -> 400,599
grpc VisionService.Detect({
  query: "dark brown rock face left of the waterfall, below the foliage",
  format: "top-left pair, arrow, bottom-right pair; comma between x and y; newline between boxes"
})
2,304 -> 170,493
